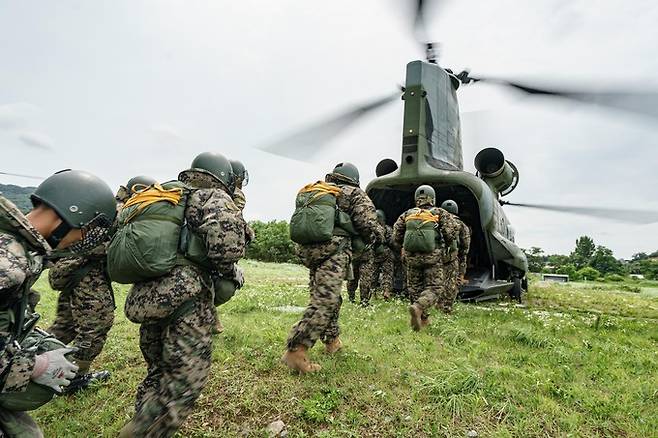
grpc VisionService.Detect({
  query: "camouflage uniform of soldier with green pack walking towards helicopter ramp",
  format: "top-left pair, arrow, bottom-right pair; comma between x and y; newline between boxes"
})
393,207 -> 459,319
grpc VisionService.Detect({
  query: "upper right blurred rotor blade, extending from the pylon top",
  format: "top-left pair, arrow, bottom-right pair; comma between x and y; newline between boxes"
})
467,77 -> 658,118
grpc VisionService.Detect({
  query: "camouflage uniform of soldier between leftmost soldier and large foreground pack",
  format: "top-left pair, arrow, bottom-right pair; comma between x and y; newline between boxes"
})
48,245 -> 116,366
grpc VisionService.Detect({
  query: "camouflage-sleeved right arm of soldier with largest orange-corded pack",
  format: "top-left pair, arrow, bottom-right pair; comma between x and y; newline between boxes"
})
186,189 -> 246,276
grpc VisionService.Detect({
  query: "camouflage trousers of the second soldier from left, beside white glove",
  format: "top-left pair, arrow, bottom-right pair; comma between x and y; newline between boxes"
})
47,268 -> 115,361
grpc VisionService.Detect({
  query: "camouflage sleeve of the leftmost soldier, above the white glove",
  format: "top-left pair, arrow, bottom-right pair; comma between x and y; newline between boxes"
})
0,240 -> 36,392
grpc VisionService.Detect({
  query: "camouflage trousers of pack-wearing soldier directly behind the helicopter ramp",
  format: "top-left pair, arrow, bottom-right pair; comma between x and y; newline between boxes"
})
404,250 -> 445,318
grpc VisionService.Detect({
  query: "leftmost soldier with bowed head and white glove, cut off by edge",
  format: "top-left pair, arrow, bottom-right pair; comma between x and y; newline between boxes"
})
0,170 -> 116,437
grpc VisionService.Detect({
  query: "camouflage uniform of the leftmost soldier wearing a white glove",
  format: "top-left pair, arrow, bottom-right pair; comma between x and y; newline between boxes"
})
0,196 -> 50,437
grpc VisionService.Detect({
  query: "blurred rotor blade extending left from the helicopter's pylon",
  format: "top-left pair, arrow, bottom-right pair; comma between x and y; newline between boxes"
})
258,92 -> 400,162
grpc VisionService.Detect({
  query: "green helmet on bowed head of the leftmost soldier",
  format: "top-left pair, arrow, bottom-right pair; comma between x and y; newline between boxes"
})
30,169 -> 117,248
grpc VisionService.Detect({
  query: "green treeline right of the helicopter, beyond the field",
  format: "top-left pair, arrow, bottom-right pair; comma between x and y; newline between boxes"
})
524,236 -> 658,281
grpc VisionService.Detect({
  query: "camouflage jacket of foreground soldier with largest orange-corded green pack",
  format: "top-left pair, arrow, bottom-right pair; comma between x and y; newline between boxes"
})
125,170 -> 245,322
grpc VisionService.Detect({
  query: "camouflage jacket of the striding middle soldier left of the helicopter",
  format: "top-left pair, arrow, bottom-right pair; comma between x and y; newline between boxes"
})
297,184 -> 384,266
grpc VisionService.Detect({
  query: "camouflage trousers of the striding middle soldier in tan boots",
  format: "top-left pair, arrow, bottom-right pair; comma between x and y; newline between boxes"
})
287,251 -> 350,350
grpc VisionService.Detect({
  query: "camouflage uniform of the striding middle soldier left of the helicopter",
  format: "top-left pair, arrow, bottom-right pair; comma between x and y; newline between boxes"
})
287,181 -> 382,351
